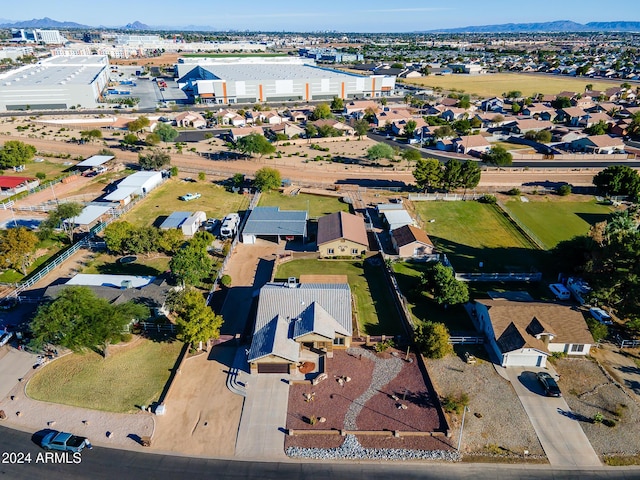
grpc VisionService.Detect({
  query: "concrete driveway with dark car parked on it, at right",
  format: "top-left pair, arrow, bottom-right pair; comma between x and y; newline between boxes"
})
505,367 -> 601,467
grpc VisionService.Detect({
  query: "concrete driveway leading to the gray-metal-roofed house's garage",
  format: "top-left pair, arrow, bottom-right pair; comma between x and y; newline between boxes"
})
236,373 -> 289,460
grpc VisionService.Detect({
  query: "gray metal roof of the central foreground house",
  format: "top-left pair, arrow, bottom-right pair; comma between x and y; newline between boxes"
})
249,283 -> 353,362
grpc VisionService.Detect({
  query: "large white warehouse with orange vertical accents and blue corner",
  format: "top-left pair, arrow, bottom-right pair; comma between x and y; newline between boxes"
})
175,57 -> 396,104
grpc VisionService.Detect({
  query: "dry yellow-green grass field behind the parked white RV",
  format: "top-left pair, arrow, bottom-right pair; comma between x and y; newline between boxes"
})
123,179 -> 249,225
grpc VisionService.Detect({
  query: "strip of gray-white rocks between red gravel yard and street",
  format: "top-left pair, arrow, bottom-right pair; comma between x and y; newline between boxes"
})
287,435 -> 460,462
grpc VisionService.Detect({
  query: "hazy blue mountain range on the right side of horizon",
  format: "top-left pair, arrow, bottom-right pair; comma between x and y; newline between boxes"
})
423,20 -> 640,33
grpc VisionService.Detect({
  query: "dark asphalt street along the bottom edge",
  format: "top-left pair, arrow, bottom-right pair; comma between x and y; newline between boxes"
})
0,427 -> 640,480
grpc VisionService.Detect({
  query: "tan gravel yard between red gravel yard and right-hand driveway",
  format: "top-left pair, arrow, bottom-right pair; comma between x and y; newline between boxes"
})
427,346 -> 544,458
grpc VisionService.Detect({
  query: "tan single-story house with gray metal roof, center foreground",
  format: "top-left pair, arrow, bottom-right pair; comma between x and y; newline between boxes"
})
247,280 -> 353,374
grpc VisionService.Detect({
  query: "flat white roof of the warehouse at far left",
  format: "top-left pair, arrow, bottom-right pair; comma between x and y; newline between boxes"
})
0,55 -> 108,87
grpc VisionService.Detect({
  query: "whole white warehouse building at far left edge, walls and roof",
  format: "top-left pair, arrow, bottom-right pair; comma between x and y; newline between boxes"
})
0,55 -> 109,111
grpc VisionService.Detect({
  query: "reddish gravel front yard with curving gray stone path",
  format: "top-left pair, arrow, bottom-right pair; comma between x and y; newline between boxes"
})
285,348 -> 451,450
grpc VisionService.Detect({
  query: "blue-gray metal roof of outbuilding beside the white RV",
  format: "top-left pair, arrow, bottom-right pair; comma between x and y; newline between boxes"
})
242,207 -> 308,236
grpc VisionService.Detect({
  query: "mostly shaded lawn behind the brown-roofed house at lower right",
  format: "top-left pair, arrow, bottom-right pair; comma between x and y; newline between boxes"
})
393,262 -> 474,332
